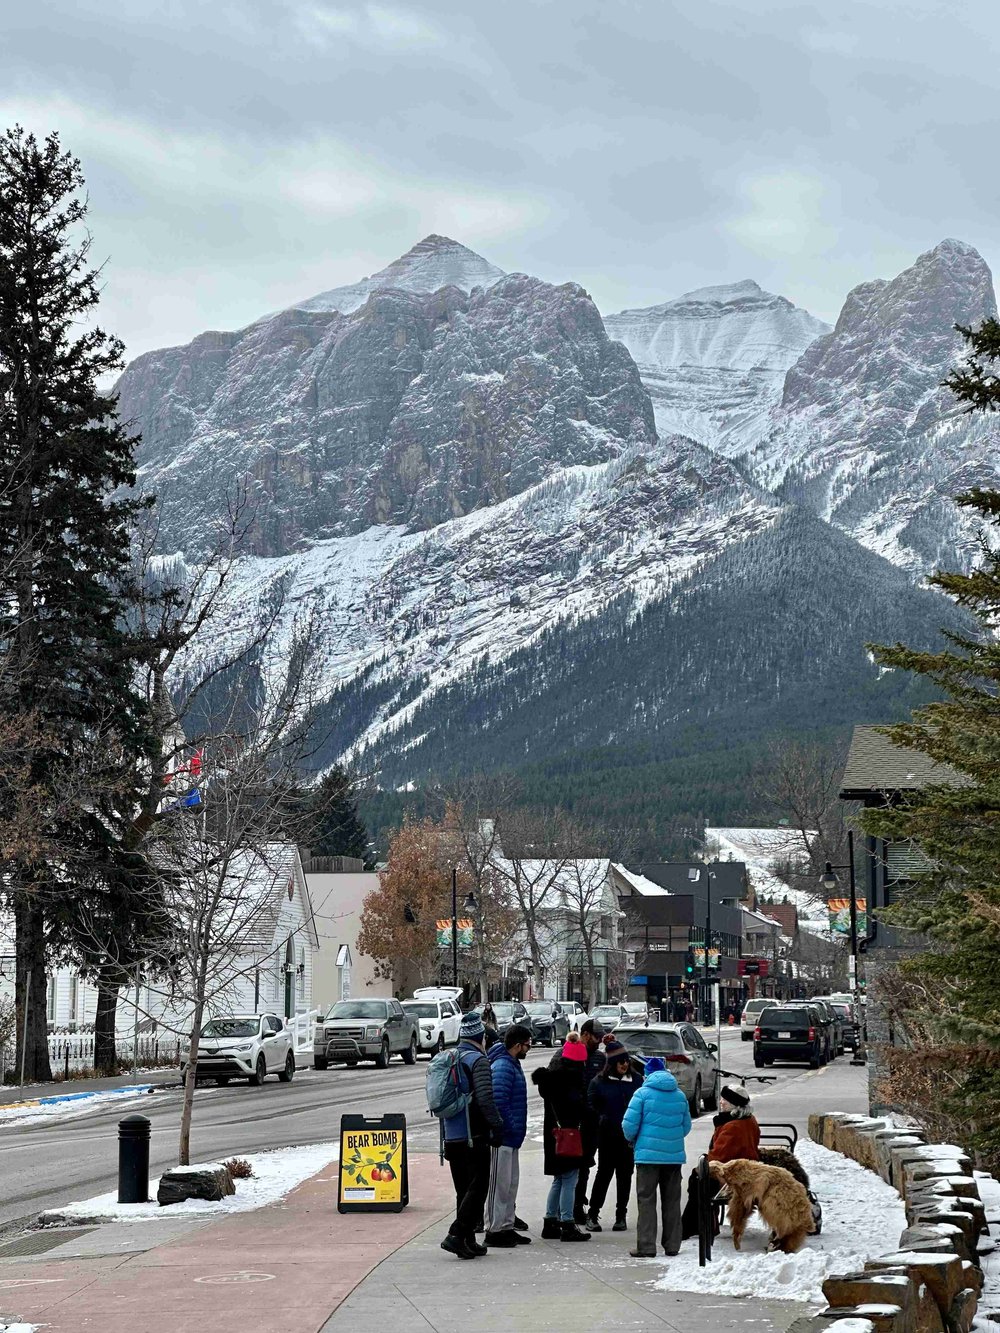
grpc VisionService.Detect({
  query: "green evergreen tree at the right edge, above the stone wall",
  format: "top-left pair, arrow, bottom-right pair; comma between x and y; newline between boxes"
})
863,320 -> 1000,1164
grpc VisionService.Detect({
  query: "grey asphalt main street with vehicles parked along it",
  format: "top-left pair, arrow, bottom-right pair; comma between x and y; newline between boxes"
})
0,1030 -> 867,1228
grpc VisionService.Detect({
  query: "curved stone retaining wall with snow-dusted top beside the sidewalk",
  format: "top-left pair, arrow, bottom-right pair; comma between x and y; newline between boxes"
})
788,1112 -> 987,1333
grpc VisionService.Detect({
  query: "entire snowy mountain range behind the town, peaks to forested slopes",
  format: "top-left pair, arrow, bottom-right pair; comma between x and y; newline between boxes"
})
119,237 -> 992,831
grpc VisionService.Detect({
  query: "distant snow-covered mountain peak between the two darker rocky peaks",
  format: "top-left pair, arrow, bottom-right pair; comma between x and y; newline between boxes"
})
604,281 -> 829,455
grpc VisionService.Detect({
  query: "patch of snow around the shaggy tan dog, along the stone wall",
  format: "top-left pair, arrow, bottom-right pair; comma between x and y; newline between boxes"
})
655,1140 -> 907,1305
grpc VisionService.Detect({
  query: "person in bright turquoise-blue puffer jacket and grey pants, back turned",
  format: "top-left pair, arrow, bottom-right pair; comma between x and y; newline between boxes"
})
621,1056 -> 691,1258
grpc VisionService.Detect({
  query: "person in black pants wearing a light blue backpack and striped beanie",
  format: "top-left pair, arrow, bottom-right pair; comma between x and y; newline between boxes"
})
441,1010 -> 504,1258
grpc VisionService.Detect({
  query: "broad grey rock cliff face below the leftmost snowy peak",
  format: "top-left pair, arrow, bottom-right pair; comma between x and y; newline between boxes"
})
119,249 -> 656,555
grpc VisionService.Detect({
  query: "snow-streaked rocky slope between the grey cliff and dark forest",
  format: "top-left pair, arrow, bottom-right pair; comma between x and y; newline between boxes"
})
184,440 -> 781,745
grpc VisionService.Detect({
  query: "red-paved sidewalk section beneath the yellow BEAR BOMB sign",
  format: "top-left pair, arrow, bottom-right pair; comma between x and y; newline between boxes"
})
0,1153 -> 455,1333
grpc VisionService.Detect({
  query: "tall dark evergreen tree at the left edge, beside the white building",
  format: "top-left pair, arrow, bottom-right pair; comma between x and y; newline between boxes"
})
0,127 -> 149,1078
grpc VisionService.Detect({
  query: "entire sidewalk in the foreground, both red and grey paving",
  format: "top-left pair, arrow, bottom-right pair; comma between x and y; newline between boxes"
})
0,1142 -> 803,1333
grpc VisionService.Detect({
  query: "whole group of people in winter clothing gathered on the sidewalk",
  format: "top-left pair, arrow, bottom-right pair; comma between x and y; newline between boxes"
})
441,1012 -> 756,1260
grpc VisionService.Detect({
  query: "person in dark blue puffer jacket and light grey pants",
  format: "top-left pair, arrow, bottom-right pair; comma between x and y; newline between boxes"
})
487,1022 -> 531,1249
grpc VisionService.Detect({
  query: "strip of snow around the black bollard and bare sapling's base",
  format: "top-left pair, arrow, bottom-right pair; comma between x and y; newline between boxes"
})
41,1144 -> 340,1222
